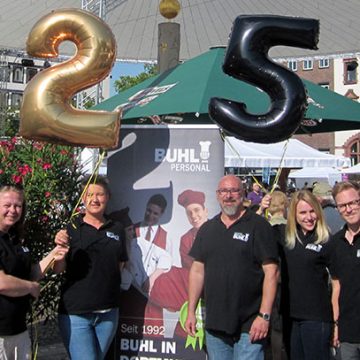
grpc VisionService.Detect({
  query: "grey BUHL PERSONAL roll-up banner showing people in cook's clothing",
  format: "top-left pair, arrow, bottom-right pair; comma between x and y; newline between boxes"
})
107,125 -> 224,360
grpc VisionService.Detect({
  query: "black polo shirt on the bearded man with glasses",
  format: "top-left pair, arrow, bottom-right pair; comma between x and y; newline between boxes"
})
189,211 -> 278,335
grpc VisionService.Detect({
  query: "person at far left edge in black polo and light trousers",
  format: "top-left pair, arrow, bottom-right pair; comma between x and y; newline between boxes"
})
0,185 -> 67,360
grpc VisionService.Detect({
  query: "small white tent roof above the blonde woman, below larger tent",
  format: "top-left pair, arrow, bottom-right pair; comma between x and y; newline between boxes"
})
289,167 -> 342,188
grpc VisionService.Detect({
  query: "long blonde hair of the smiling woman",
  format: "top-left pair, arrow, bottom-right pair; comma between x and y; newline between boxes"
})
285,190 -> 329,249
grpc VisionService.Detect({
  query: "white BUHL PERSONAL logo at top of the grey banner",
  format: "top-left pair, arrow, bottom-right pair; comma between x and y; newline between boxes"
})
154,141 -> 211,172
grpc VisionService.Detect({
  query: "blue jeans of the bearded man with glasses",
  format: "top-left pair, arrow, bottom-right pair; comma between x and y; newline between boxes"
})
205,331 -> 265,360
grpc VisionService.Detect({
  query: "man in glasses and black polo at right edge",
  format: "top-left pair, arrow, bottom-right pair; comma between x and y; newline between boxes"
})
330,181 -> 360,360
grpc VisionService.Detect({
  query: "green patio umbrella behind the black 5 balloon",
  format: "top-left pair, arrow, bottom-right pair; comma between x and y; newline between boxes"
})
93,48 -> 360,133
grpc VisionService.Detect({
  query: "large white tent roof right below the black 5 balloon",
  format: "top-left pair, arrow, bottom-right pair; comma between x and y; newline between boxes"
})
225,136 -> 350,168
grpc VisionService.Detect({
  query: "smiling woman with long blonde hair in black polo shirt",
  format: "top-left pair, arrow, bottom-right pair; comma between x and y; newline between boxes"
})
276,190 -> 332,360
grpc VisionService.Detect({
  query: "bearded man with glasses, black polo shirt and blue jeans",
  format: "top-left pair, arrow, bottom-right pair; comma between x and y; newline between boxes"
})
185,175 -> 278,360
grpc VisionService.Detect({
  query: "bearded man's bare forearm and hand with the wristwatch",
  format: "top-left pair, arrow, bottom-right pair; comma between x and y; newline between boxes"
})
249,262 -> 279,342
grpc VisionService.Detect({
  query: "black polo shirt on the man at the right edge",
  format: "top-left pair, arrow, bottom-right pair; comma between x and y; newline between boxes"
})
330,226 -> 360,343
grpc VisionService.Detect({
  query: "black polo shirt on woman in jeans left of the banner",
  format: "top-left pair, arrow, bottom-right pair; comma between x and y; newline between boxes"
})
59,216 -> 128,314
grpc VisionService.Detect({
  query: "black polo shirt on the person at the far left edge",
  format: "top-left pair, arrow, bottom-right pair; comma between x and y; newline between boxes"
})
0,232 -> 31,336
